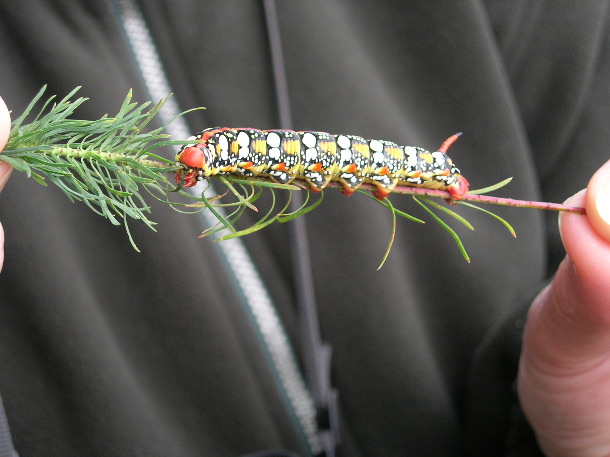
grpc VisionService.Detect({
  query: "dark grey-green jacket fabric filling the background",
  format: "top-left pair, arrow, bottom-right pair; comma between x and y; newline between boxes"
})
0,0 -> 610,457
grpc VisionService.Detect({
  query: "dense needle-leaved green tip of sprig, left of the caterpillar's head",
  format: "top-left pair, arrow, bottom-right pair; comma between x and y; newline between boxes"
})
0,87 -> 177,250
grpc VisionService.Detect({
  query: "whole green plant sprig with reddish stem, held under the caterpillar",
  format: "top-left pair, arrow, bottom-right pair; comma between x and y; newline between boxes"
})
0,87 -> 584,262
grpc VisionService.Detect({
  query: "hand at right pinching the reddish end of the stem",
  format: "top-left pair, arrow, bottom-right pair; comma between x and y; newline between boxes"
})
519,161 -> 610,457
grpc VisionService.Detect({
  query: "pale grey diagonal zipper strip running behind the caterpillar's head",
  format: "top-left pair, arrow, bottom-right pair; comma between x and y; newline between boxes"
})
115,0 -> 321,455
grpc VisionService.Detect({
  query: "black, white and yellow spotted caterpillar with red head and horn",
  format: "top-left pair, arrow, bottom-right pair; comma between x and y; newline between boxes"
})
176,127 -> 469,200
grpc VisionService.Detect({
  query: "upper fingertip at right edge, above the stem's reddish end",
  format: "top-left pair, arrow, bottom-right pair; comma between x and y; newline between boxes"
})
584,161 -> 610,243
